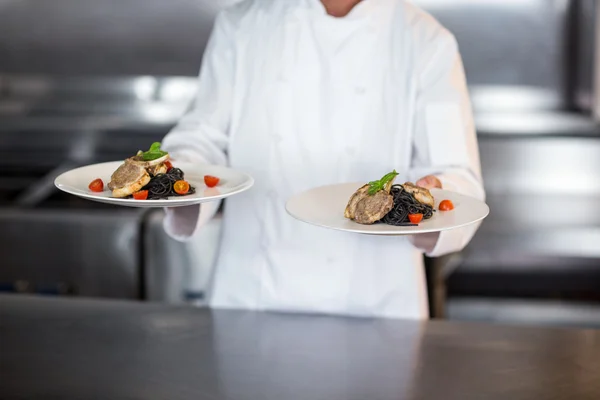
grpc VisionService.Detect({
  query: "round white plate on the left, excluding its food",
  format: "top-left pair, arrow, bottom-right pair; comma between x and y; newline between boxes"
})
54,161 -> 254,208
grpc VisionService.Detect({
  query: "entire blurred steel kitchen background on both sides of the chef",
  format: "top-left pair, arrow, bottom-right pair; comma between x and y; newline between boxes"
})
0,0 -> 600,327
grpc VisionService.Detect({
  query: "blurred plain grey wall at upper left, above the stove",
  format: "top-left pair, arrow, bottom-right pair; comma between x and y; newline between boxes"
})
0,0 -> 231,76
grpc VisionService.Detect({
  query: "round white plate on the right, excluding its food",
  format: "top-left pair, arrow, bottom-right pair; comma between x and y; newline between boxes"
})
286,183 -> 490,235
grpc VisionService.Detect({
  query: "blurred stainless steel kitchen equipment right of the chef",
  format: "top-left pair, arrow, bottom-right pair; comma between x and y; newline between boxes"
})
417,0 -> 600,324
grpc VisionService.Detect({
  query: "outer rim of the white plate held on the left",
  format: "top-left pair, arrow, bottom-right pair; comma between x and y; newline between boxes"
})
54,160 -> 255,208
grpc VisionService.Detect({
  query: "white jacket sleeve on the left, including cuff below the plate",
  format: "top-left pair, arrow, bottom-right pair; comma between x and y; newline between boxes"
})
163,13 -> 234,241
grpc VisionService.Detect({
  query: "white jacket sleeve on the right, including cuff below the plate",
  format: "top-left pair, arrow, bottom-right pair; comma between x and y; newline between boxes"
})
410,31 -> 485,257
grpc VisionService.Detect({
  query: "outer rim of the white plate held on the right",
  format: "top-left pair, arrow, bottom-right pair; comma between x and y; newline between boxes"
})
285,182 -> 490,236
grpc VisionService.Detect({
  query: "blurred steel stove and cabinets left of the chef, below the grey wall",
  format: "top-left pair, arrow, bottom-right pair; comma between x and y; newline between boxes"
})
0,75 -> 220,302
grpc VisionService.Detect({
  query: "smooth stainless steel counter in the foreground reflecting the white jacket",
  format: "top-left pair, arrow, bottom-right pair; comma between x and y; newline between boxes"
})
0,297 -> 600,400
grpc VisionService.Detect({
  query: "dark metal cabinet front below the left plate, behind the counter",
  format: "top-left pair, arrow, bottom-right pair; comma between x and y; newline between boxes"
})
0,209 -> 141,299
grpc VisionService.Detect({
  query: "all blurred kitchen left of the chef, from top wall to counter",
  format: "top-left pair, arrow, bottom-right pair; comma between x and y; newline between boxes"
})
0,0 -> 220,302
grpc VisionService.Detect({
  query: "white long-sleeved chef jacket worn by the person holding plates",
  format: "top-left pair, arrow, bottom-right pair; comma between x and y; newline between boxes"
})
163,0 -> 484,318
